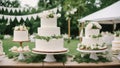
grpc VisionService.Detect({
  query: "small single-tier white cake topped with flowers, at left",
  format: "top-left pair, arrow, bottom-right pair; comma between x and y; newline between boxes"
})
13,25 -> 29,41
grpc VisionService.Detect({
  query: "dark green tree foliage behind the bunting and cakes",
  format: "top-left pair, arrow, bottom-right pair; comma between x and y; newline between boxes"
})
0,0 -> 118,37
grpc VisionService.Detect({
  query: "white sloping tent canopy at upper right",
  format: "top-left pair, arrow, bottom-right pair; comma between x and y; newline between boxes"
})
78,1 -> 120,24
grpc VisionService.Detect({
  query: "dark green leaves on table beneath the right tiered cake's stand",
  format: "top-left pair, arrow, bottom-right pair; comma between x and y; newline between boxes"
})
73,54 -> 110,63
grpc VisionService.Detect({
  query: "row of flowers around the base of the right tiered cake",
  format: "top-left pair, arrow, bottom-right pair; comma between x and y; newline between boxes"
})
78,43 -> 107,50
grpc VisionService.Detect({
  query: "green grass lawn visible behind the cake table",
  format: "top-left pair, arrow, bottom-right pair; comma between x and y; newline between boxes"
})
2,39 -> 79,55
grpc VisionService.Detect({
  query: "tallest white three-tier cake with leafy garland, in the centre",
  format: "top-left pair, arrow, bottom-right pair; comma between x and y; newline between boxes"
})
33,11 -> 67,53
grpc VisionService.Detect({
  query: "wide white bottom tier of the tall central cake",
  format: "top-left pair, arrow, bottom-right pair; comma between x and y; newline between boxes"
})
35,39 -> 64,51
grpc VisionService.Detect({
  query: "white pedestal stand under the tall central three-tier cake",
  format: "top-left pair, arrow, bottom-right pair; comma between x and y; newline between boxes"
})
32,49 -> 68,62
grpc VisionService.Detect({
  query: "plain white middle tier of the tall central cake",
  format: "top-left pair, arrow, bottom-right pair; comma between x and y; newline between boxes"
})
38,27 -> 60,36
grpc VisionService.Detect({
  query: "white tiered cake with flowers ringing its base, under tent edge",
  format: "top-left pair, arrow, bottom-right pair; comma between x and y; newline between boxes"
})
78,22 -> 107,50
